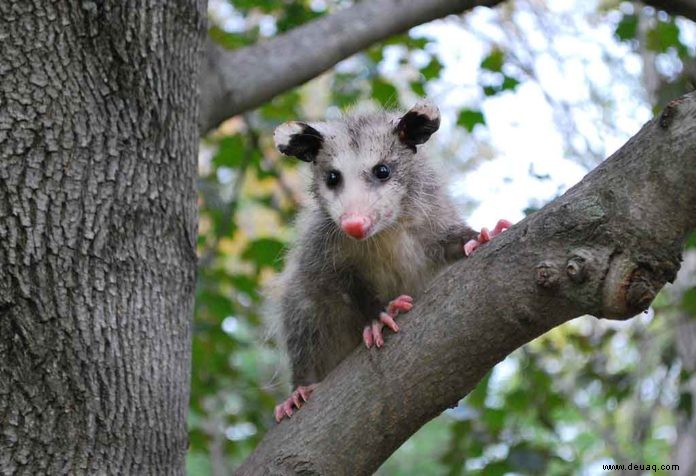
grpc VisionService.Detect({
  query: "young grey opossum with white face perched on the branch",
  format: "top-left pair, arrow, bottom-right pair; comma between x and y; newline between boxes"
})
274,101 -> 510,421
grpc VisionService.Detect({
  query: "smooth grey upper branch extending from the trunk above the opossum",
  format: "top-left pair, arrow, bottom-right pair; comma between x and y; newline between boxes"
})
200,0 -> 502,132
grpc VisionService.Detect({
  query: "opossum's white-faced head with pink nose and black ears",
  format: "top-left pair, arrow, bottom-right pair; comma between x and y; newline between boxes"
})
274,102 -> 440,240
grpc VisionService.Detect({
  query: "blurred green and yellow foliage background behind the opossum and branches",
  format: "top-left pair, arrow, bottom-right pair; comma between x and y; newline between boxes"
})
187,0 -> 696,475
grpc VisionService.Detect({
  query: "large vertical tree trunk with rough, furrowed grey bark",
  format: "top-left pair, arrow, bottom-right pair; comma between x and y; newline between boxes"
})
0,0 -> 206,475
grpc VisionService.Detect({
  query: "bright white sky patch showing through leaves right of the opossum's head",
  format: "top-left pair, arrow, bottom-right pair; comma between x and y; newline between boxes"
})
414,0 -> 651,228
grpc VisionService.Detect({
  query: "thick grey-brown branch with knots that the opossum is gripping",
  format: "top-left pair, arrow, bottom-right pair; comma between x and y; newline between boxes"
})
238,93 -> 696,475
